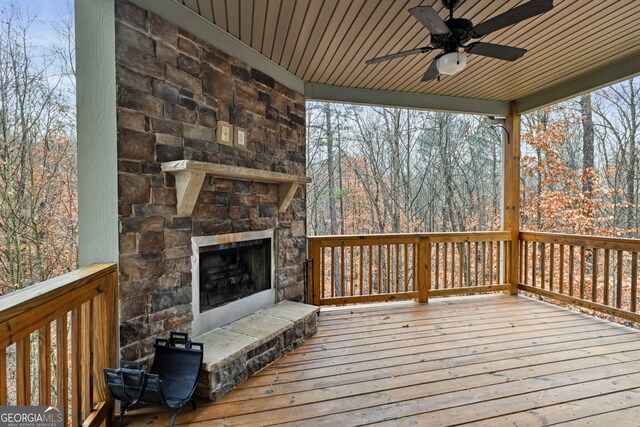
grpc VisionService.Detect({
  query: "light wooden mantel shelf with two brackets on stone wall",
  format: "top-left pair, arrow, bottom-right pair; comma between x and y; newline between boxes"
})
162,160 -> 311,216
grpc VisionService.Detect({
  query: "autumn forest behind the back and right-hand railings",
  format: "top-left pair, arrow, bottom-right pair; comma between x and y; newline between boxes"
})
307,78 -> 640,241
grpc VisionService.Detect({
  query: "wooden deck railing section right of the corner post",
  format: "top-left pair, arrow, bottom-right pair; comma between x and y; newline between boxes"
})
518,232 -> 640,322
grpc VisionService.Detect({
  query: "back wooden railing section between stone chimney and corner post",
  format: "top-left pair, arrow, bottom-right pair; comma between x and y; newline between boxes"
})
309,232 -> 511,305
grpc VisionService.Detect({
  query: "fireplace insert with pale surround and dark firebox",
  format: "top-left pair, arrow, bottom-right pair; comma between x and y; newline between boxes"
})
191,229 -> 276,335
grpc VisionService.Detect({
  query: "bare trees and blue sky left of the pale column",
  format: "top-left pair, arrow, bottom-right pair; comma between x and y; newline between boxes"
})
0,1 -> 78,295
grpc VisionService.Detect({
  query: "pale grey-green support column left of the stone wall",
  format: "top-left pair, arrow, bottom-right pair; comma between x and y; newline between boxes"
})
75,0 -> 118,266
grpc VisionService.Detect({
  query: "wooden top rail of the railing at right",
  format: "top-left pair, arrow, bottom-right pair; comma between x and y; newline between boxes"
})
520,231 -> 640,252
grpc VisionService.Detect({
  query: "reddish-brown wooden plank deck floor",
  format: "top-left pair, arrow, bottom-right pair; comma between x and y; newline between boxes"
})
127,295 -> 640,427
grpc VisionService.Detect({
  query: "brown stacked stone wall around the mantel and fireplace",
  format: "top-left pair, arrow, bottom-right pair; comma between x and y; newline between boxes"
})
115,0 -> 306,359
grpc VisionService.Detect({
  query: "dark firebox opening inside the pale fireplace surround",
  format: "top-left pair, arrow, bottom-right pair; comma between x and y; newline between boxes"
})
199,238 -> 271,313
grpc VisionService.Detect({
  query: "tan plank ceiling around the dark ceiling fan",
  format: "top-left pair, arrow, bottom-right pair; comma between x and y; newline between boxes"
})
176,0 -> 640,101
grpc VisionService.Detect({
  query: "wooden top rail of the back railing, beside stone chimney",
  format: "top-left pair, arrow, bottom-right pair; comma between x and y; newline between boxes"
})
309,231 -> 511,243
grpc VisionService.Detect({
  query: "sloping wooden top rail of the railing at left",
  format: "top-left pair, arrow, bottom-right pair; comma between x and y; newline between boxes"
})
0,264 -> 116,324
